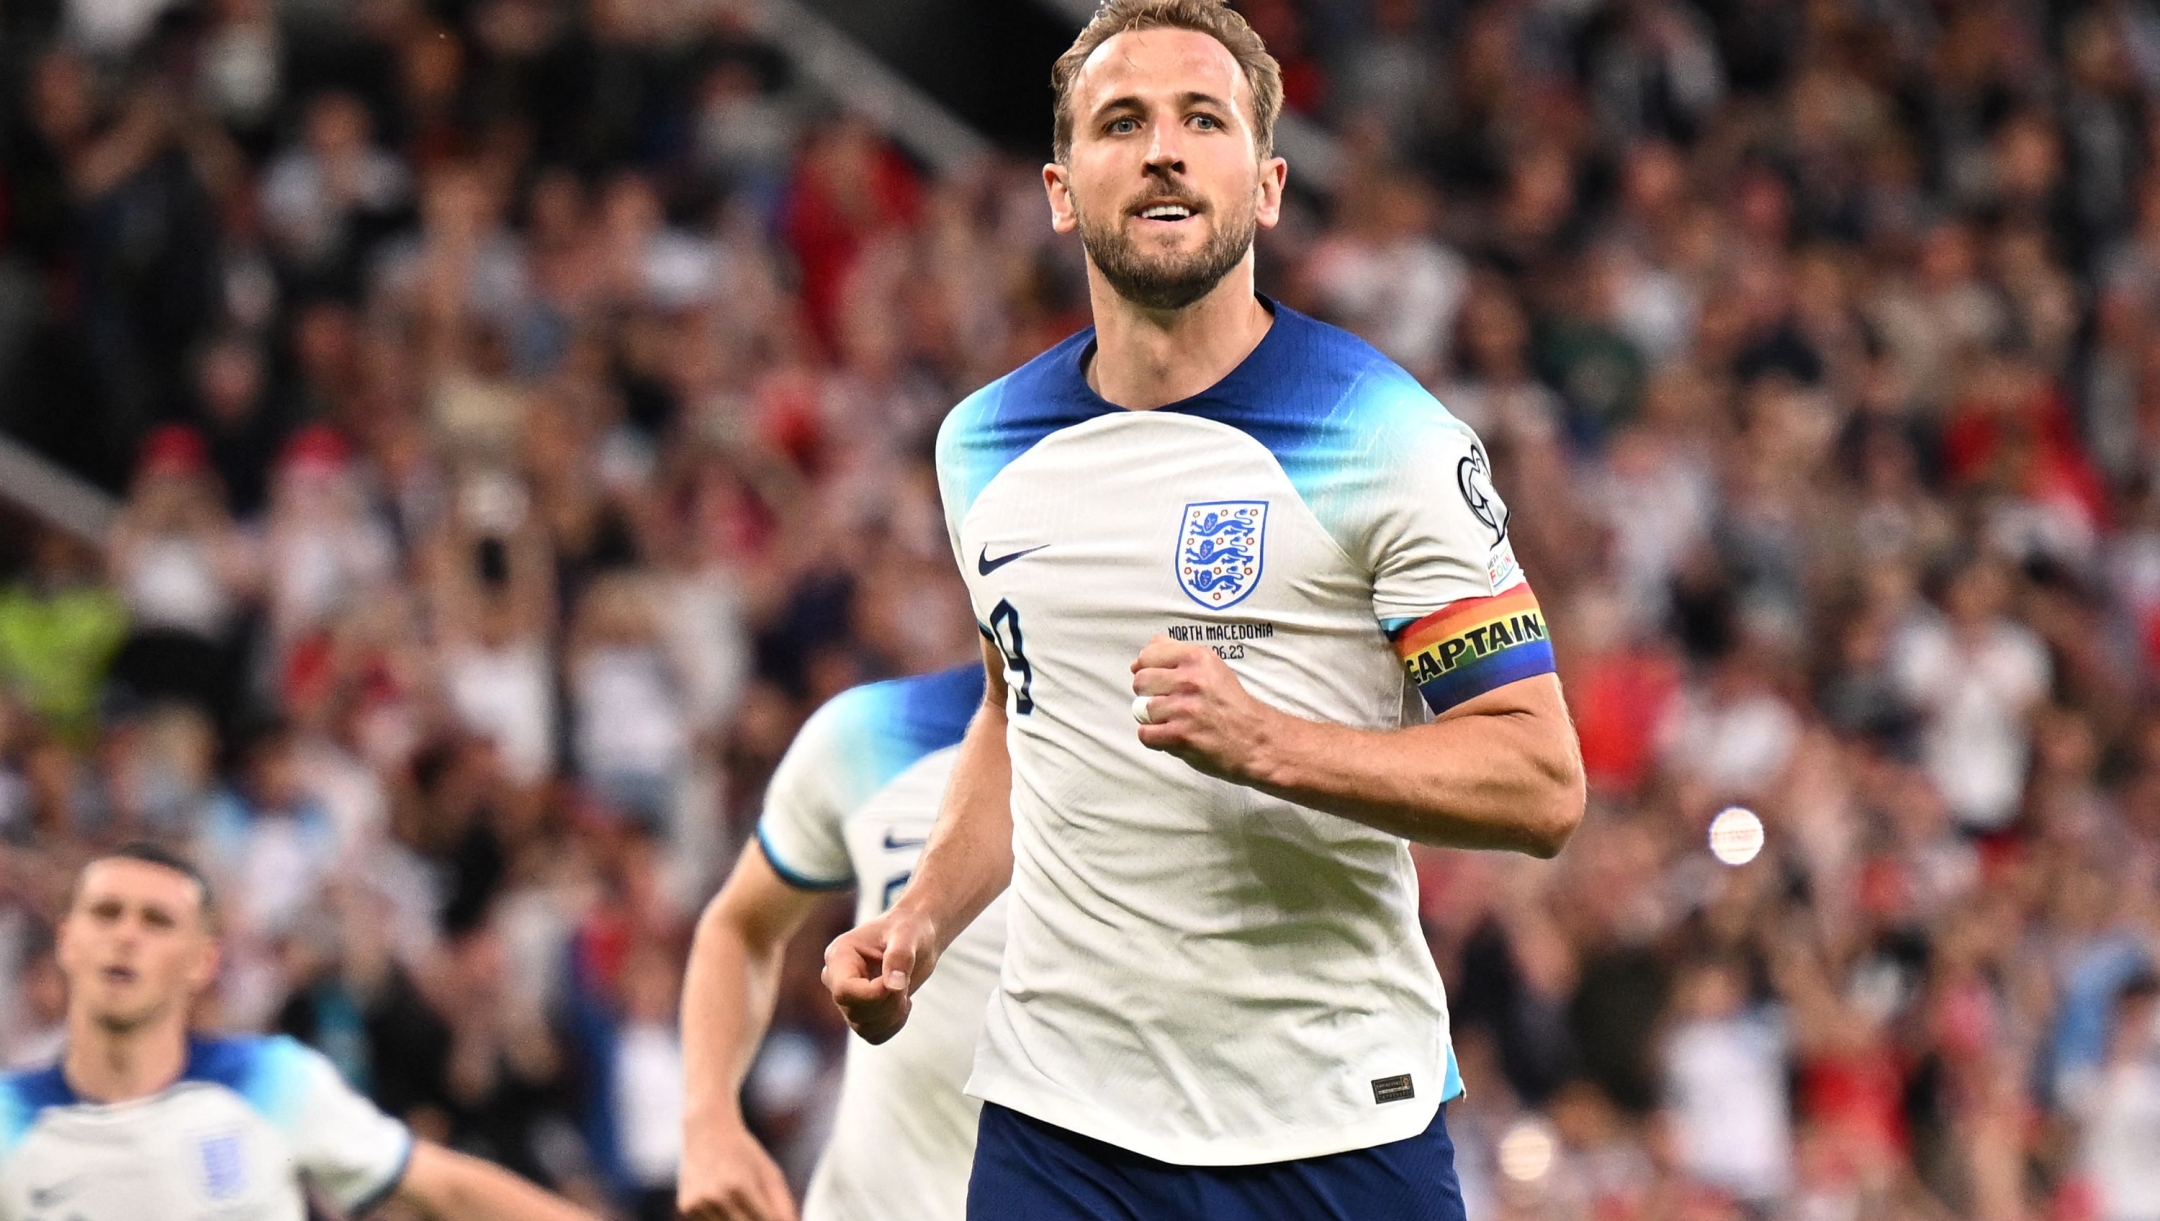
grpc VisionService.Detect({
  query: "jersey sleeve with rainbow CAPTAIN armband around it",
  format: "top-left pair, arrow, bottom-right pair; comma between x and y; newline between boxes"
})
1367,413 -> 1553,713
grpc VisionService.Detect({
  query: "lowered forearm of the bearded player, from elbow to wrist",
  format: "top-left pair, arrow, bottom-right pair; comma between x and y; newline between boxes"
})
899,702 -> 1013,949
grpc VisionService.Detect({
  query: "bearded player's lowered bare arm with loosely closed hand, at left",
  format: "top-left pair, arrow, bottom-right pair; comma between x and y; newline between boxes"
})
825,642 -> 1013,1044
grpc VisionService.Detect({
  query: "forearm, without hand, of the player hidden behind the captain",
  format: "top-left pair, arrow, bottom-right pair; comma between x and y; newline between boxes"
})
683,899 -> 782,1126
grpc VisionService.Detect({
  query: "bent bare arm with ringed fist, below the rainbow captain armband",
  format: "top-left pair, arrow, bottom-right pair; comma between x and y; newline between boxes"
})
1132,638 -> 1583,856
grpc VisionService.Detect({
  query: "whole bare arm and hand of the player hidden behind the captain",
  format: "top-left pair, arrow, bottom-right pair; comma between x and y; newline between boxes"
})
676,841 -> 819,1221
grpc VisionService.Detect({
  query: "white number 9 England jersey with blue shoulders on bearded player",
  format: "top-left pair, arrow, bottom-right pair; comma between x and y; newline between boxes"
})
937,303 -> 1553,1165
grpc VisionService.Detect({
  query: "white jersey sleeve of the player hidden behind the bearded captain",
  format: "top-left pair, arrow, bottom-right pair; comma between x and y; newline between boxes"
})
758,694 -> 860,890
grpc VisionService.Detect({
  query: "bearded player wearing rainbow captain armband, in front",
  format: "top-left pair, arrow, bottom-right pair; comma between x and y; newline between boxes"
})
825,0 -> 1583,1221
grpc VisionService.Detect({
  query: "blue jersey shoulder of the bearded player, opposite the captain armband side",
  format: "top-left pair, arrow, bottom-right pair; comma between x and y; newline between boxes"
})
937,328 -> 1102,514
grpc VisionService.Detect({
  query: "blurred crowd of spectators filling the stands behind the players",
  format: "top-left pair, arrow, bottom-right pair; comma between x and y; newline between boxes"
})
0,0 -> 2160,1221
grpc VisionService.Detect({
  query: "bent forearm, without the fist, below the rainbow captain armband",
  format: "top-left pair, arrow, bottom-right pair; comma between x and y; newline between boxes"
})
1238,687 -> 1583,856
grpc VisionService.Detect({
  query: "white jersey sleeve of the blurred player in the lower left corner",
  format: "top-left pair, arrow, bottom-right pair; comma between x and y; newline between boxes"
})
268,1039 -> 413,1217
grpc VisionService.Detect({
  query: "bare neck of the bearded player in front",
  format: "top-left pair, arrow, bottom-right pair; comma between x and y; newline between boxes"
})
1086,255 -> 1274,411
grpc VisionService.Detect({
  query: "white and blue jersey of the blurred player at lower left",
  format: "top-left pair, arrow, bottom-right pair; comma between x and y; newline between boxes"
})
0,1037 -> 413,1221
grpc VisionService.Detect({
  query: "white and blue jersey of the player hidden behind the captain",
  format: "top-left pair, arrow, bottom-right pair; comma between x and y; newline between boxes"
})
758,666 -> 1004,1221
